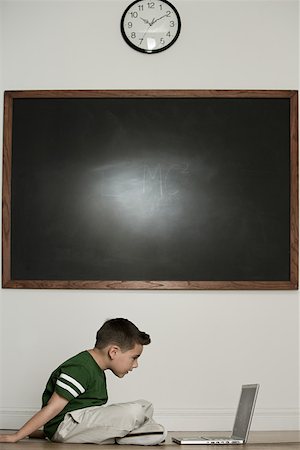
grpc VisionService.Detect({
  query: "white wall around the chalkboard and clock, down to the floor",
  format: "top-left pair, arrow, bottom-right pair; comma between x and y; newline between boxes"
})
0,0 -> 300,430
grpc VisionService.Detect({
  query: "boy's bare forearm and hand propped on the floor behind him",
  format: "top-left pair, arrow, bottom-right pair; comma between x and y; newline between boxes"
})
0,392 -> 69,442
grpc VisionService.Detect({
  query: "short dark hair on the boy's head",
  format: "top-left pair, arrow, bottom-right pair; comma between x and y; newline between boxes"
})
95,318 -> 151,351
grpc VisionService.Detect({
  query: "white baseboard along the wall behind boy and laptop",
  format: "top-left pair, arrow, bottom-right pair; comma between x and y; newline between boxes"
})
0,407 -> 300,431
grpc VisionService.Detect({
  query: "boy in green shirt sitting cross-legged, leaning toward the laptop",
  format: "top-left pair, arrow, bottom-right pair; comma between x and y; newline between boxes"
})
0,318 -> 166,445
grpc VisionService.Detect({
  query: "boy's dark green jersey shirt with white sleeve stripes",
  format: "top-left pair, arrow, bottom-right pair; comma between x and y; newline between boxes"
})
42,350 -> 107,439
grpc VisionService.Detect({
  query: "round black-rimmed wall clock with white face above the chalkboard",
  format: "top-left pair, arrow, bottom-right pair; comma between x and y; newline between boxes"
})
121,0 -> 181,53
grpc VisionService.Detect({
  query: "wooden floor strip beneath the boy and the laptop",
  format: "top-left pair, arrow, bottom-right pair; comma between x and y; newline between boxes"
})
0,431 -> 300,450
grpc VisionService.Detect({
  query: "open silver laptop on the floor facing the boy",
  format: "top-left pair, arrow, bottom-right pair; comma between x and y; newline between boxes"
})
172,384 -> 259,445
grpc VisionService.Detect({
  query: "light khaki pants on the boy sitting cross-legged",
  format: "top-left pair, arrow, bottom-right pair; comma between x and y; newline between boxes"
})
52,400 -> 164,445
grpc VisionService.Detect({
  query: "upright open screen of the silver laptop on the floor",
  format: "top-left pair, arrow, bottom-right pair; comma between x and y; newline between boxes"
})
232,384 -> 259,440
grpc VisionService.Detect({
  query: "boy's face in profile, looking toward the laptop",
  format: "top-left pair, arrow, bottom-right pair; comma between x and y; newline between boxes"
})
110,344 -> 143,378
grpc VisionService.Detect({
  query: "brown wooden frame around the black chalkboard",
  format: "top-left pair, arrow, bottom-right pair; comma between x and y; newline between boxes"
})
2,90 -> 298,290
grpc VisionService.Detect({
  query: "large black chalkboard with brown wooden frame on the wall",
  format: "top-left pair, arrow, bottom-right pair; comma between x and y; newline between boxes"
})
2,90 -> 298,289
